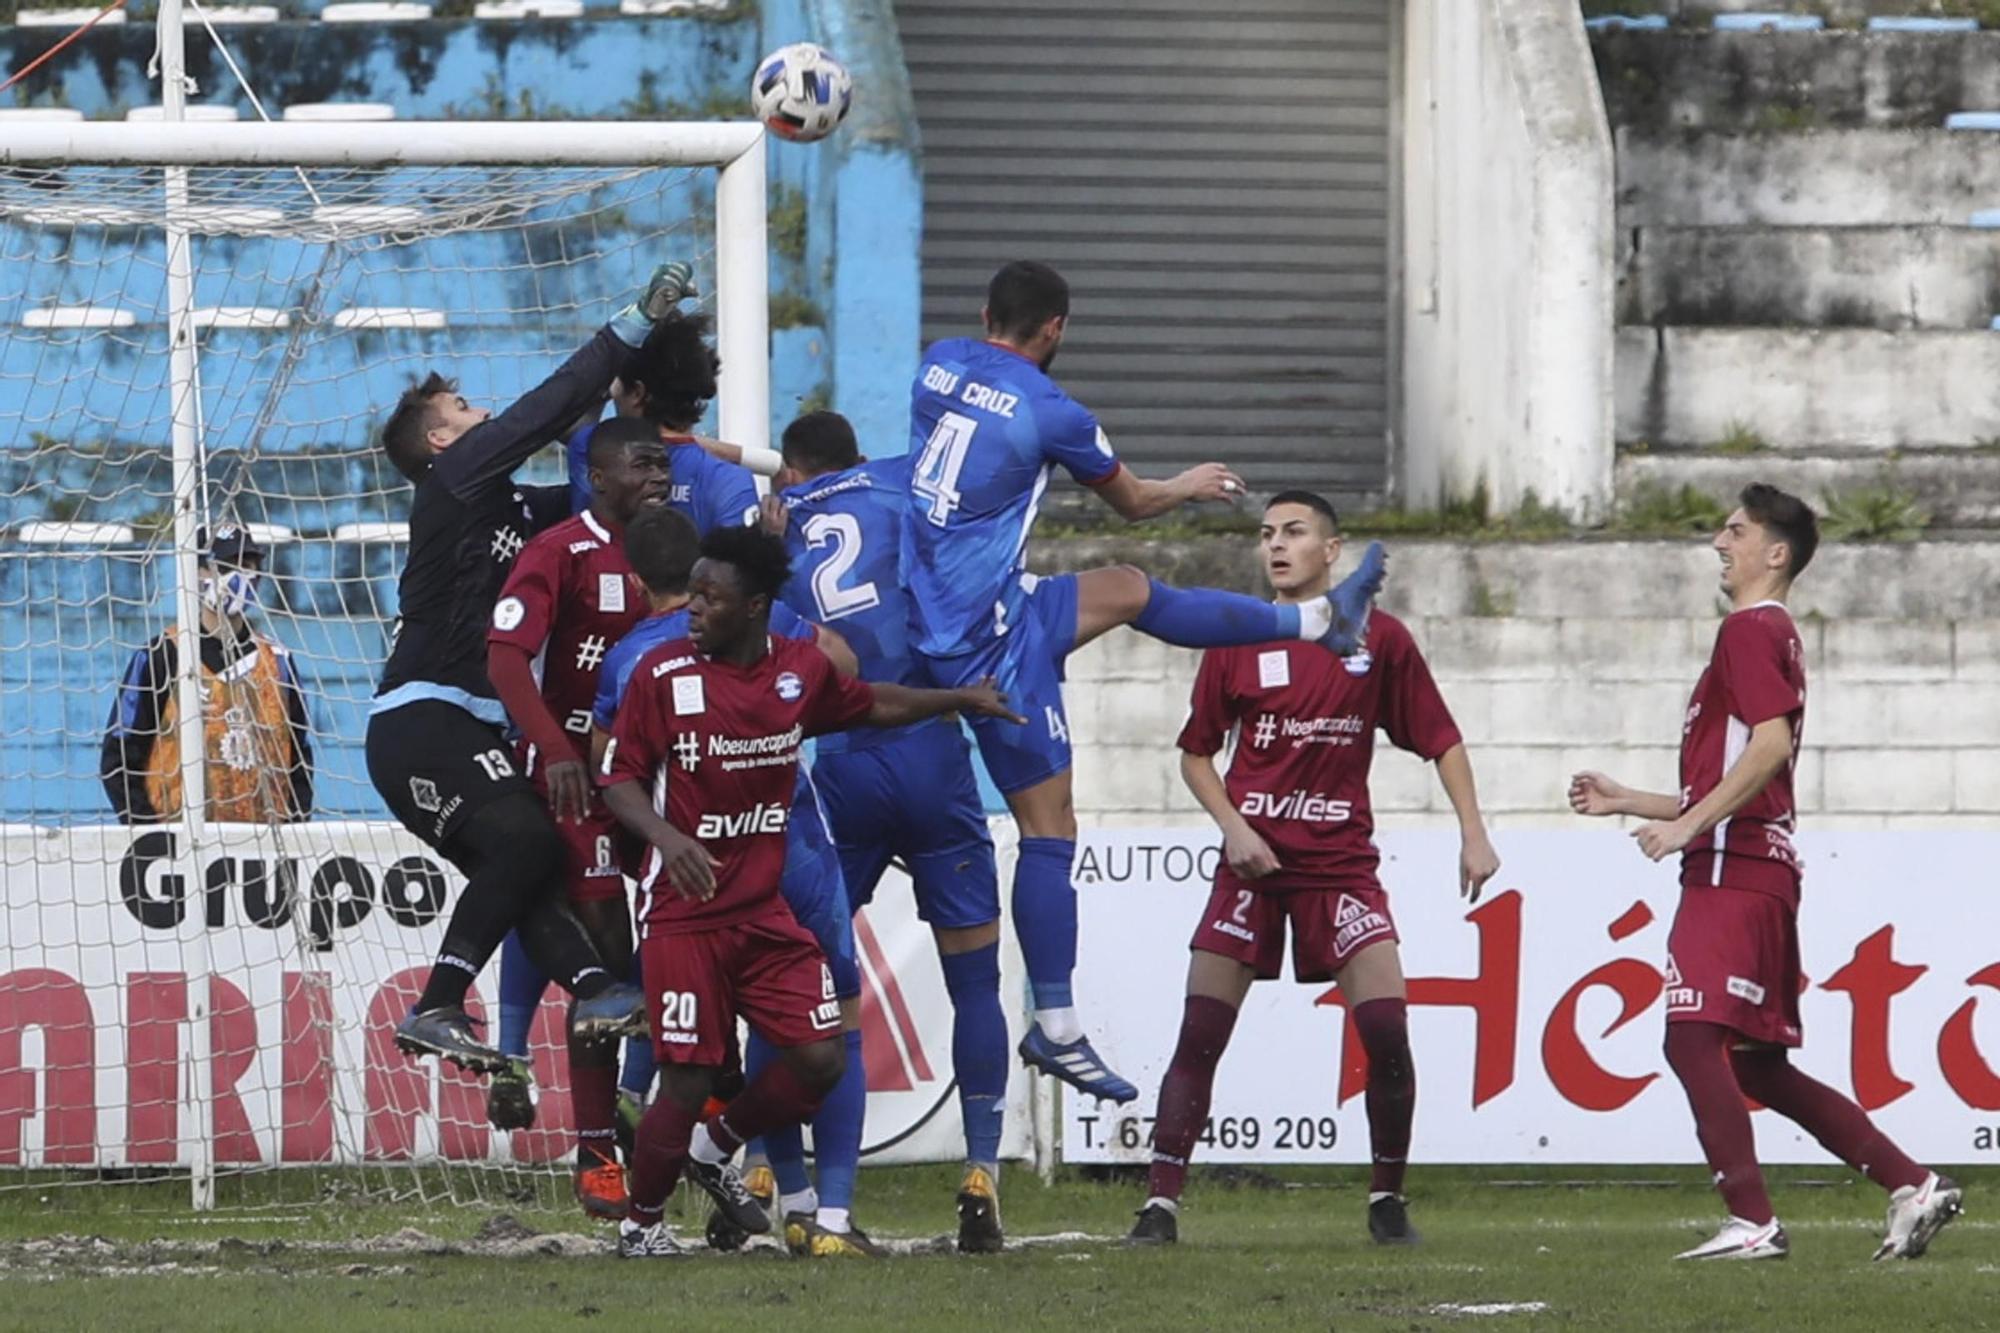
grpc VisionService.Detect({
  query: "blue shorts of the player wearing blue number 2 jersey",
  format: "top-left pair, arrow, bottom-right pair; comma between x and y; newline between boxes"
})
814,723 -> 1000,929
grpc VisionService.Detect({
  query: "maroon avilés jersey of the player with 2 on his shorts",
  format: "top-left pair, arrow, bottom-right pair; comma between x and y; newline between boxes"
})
1180,610 -> 1460,893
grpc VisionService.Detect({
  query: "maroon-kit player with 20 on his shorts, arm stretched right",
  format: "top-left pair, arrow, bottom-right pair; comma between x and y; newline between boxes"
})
600,528 -> 1022,1257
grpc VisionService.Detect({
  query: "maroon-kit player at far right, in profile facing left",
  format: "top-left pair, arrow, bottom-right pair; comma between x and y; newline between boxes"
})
1570,484 -> 1962,1259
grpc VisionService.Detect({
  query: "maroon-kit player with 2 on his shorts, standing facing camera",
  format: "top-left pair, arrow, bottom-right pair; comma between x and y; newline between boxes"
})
1132,490 -> 1500,1245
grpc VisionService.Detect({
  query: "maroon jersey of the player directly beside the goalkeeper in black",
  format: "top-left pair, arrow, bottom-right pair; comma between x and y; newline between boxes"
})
486,510 -> 648,775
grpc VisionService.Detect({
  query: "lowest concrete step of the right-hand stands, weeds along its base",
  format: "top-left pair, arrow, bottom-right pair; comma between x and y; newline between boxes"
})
1614,450 -> 2000,532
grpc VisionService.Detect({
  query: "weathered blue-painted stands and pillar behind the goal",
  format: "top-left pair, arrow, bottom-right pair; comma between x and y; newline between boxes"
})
0,0 -> 922,821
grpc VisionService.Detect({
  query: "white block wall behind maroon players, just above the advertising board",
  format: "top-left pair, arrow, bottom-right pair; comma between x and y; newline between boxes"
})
1066,608 -> 2000,829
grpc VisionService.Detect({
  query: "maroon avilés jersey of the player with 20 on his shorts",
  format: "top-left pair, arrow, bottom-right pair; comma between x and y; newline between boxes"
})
598,636 -> 874,933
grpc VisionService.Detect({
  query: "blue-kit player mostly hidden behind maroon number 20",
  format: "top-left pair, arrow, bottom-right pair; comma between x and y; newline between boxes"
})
590,510 -> 880,1257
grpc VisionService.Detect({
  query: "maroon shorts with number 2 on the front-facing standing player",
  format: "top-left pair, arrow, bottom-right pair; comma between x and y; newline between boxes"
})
1188,885 -> 1396,981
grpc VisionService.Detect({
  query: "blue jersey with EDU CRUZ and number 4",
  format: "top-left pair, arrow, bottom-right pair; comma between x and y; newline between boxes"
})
902,338 -> 1118,656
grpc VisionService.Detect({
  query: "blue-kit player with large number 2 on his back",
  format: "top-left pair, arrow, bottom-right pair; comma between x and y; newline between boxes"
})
772,412 -> 1006,1253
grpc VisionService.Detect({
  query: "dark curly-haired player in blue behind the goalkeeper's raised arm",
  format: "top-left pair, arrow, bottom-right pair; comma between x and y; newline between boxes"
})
566,314 -> 758,536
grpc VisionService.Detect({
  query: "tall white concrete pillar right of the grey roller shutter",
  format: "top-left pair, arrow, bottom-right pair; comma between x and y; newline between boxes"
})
1398,0 -> 1614,520
